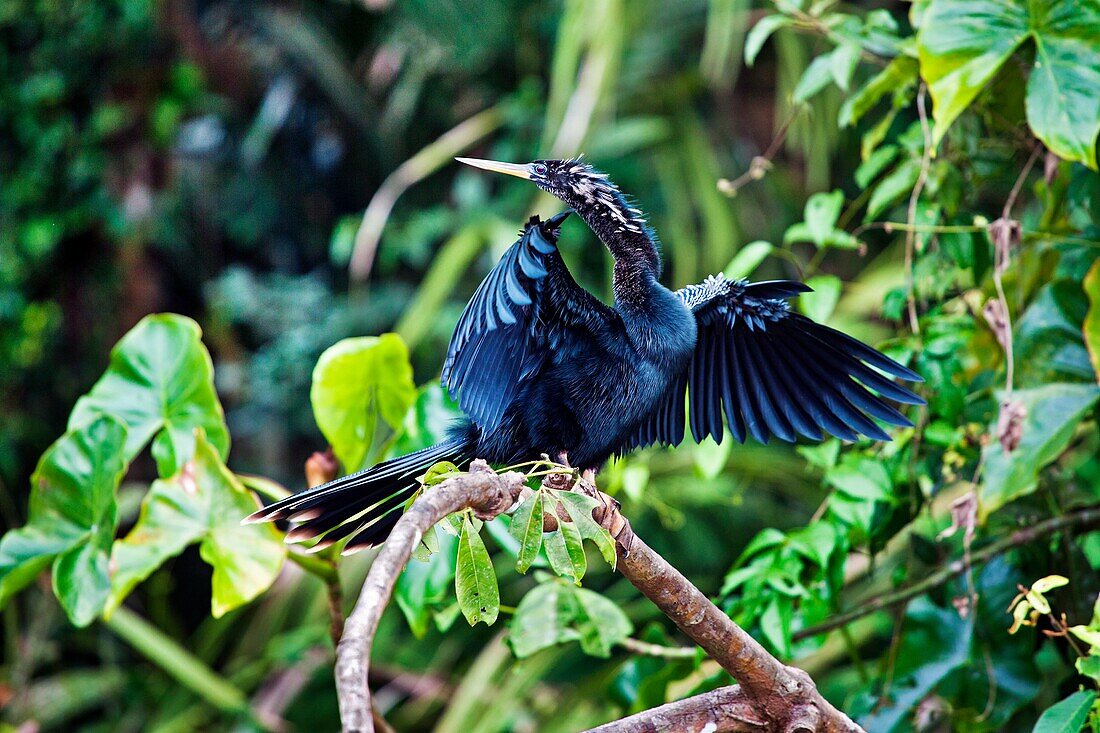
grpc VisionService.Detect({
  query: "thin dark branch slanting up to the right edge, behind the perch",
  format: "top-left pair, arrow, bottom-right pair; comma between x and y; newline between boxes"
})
792,505 -> 1100,642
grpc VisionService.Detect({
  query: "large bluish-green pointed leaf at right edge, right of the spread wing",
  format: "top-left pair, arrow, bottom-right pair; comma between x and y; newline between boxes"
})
979,384 -> 1100,521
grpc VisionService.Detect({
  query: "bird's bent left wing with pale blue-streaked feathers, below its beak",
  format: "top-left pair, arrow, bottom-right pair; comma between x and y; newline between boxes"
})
441,211 -> 618,430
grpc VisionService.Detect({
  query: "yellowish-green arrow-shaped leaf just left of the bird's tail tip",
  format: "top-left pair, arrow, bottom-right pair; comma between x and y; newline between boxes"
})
107,430 -> 286,619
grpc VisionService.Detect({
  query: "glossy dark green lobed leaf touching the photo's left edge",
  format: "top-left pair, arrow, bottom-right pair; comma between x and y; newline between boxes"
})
0,415 -> 127,626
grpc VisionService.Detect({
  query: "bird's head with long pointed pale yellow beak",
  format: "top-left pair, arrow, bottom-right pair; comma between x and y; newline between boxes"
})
455,157 -> 646,235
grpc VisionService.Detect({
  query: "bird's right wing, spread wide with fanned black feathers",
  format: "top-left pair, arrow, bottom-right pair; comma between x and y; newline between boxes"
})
623,275 -> 924,451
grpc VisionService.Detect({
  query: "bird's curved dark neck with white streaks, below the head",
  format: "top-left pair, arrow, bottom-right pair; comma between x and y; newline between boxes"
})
568,192 -> 661,308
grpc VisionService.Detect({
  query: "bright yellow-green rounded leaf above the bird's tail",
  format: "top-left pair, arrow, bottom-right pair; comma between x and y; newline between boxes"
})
309,333 -> 417,471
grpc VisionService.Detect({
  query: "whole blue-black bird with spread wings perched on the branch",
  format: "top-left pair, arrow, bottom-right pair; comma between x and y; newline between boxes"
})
249,158 -> 923,551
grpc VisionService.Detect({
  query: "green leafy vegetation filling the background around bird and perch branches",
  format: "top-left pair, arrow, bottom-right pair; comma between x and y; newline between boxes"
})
0,0 -> 1100,733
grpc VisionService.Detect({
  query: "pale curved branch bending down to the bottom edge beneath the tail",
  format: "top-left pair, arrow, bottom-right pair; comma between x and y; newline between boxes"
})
336,461 -> 524,733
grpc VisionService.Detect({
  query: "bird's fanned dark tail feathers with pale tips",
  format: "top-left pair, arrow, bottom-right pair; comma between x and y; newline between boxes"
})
244,430 -> 476,555
